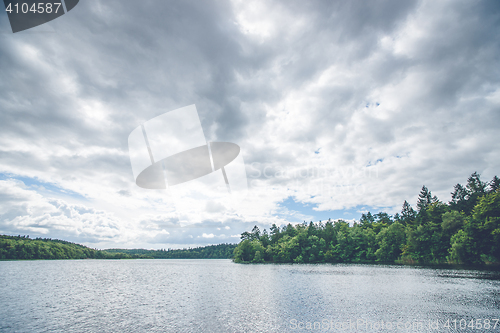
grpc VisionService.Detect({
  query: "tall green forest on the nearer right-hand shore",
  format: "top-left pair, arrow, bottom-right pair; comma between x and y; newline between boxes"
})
234,172 -> 500,264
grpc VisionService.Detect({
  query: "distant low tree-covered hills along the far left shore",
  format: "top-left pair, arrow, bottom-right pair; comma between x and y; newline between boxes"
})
0,235 -> 236,260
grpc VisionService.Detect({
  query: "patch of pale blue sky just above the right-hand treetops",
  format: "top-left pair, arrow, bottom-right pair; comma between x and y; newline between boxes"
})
279,196 -> 391,222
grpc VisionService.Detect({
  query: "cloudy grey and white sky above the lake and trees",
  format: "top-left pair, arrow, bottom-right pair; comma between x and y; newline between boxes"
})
0,0 -> 500,249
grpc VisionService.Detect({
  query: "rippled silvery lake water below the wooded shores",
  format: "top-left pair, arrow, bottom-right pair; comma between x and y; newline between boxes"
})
0,259 -> 500,332
